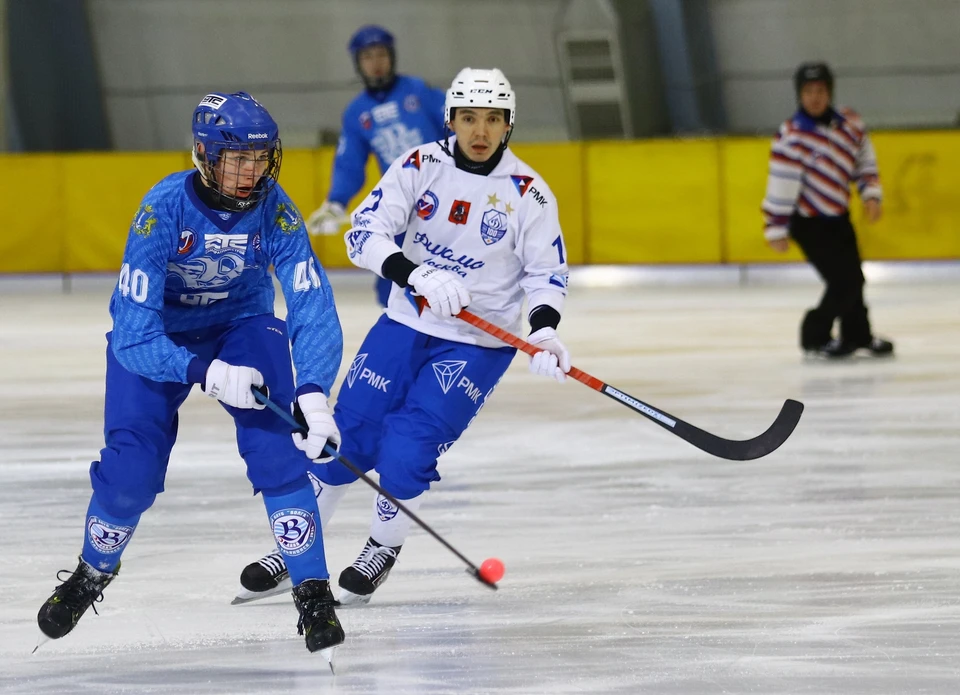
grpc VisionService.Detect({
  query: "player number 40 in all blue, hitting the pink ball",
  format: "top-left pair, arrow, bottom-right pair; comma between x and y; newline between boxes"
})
37,92 -> 344,657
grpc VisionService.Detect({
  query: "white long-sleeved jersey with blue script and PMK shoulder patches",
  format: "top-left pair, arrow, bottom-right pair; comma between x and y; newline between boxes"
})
346,138 -> 567,347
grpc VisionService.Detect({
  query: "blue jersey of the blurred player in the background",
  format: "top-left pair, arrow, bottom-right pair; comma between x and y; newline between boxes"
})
327,75 -> 446,207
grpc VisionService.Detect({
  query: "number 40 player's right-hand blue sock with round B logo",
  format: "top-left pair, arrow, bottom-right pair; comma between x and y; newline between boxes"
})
261,476 -> 330,586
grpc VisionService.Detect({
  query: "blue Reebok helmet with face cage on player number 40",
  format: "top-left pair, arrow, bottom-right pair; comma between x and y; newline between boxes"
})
193,92 -> 283,211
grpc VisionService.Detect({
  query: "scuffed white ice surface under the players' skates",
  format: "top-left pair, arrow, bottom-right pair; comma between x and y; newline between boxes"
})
0,279 -> 960,695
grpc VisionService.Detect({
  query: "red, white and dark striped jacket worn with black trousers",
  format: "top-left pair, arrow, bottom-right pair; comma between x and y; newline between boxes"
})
762,109 -> 882,240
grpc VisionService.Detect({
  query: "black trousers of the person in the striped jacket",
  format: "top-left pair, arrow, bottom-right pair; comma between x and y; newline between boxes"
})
790,215 -> 872,349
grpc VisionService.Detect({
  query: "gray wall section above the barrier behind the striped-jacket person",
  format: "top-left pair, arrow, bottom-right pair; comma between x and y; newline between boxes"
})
710,0 -> 960,132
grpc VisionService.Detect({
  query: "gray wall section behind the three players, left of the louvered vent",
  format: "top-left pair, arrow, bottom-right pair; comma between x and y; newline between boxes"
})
88,0 -> 567,150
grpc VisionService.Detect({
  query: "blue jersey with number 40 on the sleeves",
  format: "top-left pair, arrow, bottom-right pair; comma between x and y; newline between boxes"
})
110,170 -> 343,393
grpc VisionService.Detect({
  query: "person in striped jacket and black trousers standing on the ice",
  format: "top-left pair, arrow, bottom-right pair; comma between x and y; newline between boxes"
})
762,63 -> 893,357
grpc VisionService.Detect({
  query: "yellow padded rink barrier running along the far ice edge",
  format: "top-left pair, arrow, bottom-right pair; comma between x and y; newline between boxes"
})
0,131 -> 960,273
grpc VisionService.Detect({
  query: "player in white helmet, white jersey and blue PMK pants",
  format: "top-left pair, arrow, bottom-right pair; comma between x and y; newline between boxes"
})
241,68 -> 570,603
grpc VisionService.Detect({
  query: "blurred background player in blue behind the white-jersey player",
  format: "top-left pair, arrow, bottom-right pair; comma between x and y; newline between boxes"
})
307,26 -> 444,306
